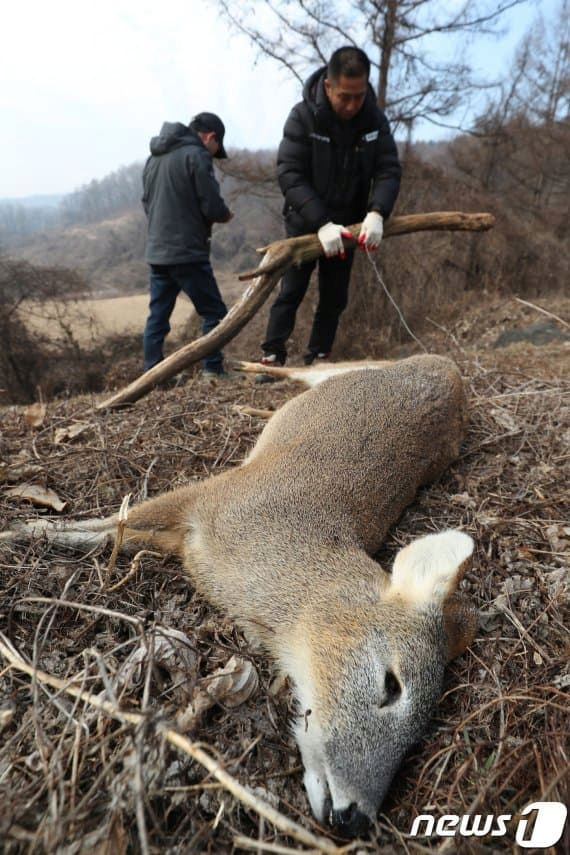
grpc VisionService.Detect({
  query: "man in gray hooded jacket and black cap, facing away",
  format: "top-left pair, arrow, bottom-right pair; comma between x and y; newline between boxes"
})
142,113 -> 233,375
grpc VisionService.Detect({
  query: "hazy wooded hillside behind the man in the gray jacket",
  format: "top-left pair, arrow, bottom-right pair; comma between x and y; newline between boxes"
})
7,151 -> 283,297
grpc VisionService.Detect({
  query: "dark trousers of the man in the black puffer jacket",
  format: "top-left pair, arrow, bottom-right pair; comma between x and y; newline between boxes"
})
261,251 -> 354,362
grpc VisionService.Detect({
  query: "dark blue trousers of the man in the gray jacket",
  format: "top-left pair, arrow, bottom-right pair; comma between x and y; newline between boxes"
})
143,261 -> 228,371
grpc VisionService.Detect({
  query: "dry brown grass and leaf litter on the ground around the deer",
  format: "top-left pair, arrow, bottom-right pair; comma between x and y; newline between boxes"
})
0,332 -> 570,855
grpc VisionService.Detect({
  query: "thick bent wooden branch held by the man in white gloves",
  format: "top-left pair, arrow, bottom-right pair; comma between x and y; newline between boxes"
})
96,211 -> 494,410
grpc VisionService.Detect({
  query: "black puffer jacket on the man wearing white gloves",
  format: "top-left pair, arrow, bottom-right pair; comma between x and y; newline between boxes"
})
277,67 -> 402,235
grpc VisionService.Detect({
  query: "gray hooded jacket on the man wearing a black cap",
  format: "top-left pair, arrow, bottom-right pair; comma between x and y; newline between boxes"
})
142,122 -> 230,264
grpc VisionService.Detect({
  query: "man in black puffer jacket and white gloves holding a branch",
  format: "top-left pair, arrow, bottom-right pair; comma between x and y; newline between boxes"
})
261,47 -> 401,368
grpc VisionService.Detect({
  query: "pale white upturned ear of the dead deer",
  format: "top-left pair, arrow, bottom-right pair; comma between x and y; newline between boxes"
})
390,529 -> 473,606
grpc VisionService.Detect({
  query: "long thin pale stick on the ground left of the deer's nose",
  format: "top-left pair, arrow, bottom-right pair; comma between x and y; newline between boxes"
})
0,633 -> 346,855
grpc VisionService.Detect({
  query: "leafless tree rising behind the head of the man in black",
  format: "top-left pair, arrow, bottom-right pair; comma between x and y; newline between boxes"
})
215,0 -> 527,136
